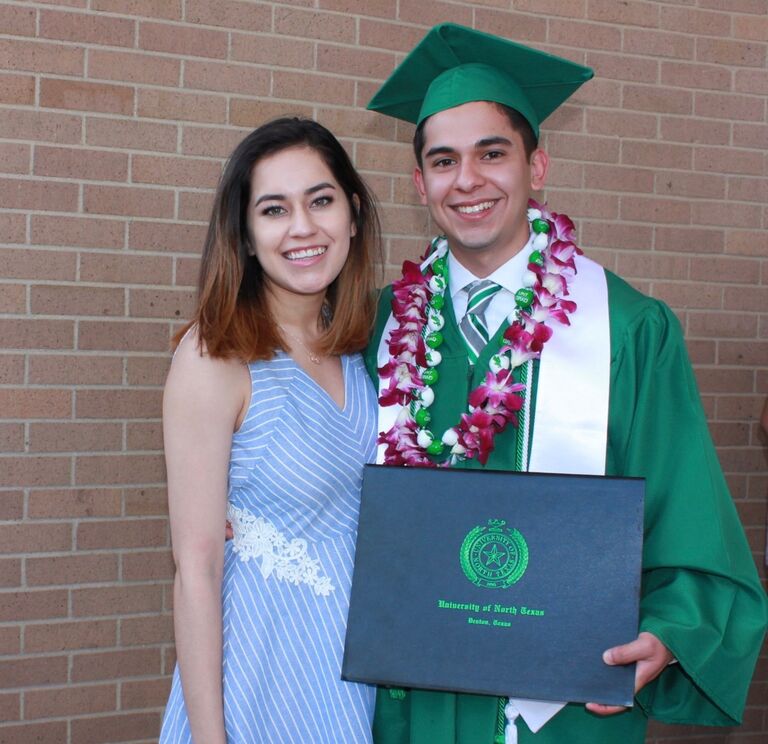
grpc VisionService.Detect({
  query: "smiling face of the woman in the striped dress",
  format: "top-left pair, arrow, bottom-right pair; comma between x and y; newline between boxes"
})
248,147 -> 355,298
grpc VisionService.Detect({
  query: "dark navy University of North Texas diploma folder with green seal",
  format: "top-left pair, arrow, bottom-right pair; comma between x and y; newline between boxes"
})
342,465 -> 644,705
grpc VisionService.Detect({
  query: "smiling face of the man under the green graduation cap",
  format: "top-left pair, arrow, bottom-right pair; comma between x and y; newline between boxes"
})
413,101 -> 548,277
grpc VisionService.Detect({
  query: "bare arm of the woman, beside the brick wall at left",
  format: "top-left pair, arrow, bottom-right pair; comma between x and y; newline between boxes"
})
163,334 -> 250,744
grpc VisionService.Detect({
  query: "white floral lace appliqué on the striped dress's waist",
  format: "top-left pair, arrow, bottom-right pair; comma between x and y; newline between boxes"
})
227,504 -> 336,597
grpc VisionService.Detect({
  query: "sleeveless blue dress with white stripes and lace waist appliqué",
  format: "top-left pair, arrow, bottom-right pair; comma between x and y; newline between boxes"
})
160,353 -> 376,744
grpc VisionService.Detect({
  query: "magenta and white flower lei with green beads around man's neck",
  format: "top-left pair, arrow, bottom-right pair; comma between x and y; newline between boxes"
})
378,199 -> 582,467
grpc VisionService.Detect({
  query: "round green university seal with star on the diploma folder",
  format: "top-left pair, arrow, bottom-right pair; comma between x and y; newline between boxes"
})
459,519 -> 528,589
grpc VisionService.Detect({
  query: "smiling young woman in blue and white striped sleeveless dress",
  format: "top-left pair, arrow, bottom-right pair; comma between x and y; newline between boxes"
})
160,119 -> 379,744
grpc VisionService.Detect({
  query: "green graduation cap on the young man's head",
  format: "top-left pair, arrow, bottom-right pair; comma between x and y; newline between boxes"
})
368,23 -> 594,137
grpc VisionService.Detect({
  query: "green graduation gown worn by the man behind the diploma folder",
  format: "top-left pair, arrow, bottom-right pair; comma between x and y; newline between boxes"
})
366,271 -> 768,744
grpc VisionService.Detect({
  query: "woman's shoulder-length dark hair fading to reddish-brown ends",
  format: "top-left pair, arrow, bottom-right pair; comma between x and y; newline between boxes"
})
181,118 -> 381,362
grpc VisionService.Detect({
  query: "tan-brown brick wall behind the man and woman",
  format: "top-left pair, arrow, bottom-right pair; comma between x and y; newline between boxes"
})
0,0 -> 768,744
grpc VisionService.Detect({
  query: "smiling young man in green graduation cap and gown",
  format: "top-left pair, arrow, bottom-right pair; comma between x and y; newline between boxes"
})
367,24 -> 766,744
